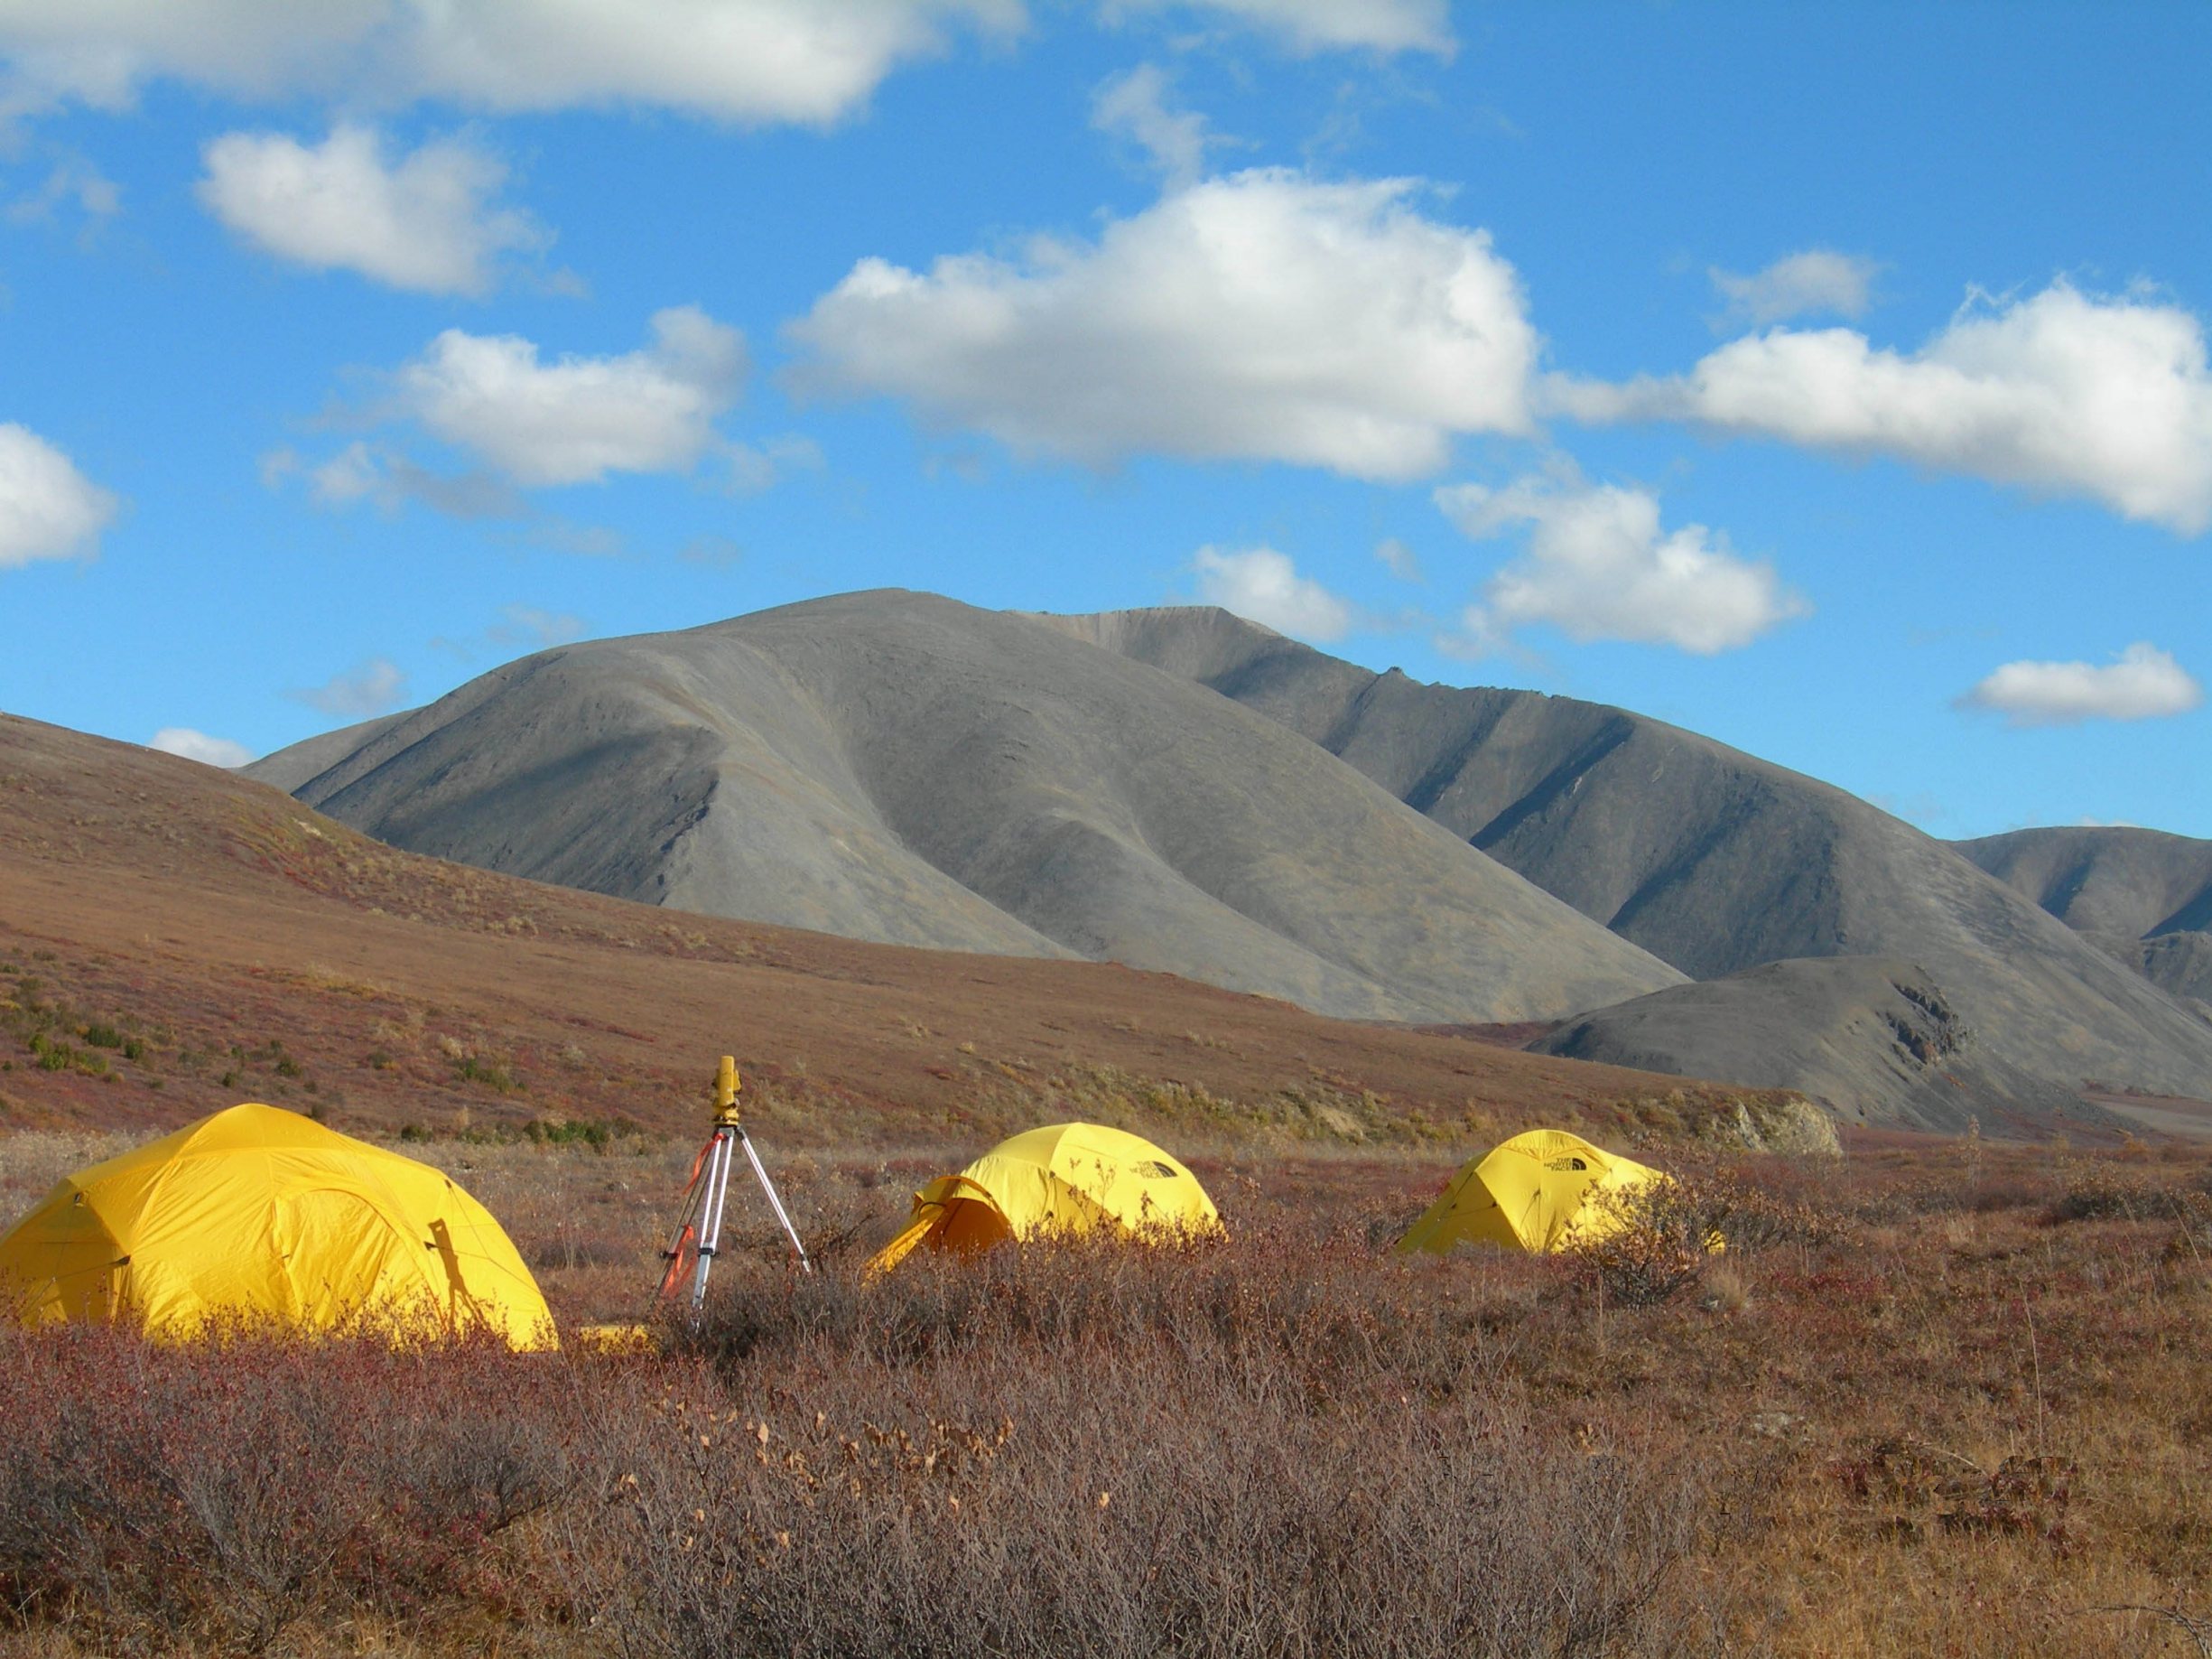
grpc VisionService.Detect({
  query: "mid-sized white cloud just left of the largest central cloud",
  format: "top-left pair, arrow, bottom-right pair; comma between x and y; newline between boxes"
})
394,305 -> 746,487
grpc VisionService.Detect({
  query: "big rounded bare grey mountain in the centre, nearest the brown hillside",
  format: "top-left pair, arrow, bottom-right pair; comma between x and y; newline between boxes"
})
250,592 -> 1681,1020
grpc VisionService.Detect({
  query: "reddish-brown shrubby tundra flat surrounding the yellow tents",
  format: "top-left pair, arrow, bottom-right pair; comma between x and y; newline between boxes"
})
0,1137 -> 2212,1659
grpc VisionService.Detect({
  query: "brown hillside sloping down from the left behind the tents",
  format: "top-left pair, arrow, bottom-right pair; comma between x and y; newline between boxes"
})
0,717 -> 1785,1143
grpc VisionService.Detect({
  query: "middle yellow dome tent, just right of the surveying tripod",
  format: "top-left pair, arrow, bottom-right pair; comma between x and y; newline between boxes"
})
867,1123 -> 1221,1272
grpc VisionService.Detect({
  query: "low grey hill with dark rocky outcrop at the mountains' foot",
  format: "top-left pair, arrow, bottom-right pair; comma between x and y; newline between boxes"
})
1529,955 -> 2114,1132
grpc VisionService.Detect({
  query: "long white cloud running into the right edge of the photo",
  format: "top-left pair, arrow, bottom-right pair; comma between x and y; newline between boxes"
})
1548,281 -> 2212,536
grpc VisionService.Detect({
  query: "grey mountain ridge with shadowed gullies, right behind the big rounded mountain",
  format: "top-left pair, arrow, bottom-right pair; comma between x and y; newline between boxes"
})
1044,609 -> 2212,1097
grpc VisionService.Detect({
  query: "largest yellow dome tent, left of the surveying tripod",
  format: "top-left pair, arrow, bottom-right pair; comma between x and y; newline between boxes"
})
0,1106 -> 557,1349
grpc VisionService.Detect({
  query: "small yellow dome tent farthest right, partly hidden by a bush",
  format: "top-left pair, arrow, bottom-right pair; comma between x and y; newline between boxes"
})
1398,1128 -> 1668,1254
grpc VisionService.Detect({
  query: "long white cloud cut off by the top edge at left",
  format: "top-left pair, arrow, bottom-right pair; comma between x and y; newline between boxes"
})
0,0 -> 1027,124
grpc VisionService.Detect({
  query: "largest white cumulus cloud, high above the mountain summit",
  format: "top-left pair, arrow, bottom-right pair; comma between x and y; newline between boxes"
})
790,171 -> 1538,480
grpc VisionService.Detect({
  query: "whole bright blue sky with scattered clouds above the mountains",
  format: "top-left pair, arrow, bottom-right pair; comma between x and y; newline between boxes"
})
0,0 -> 2212,836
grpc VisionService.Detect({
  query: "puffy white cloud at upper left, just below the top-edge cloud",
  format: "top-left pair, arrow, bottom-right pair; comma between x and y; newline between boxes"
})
200,126 -> 551,294
